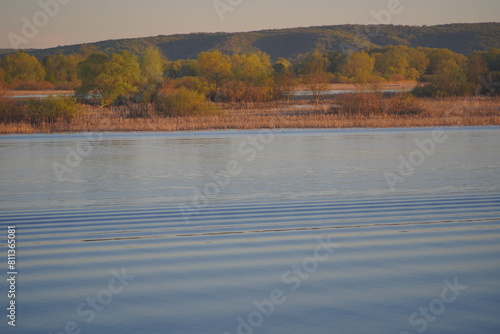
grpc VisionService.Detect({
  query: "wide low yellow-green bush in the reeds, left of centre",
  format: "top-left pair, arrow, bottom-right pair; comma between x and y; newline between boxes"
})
155,88 -> 219,117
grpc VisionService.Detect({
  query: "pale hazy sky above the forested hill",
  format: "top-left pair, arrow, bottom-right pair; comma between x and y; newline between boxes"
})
0,0 -> 500,48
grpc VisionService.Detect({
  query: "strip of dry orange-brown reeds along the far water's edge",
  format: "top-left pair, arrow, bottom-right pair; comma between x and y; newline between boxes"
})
0,97 -> 500,134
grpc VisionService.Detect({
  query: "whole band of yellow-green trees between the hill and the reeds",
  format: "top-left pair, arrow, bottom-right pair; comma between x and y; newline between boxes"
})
0,45 -> 500,105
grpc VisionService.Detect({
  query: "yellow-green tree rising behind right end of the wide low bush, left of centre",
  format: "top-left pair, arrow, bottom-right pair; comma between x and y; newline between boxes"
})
198,51 -> 231,101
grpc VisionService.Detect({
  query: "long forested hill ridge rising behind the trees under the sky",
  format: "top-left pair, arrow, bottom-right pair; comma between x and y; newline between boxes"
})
23,23 -> 500,60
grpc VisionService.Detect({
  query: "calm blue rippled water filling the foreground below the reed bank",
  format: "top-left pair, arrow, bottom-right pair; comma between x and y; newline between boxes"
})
0,128 -> 500,334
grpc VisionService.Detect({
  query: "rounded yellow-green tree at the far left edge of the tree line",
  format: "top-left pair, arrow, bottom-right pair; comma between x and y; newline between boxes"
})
2,51 -> 45,83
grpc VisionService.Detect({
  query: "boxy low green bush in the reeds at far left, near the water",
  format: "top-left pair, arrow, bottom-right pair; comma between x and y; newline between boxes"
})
26,97 -> 80,124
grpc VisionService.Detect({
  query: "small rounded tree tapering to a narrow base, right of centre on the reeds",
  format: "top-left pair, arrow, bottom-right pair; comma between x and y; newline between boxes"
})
301,52 -> 331,102
